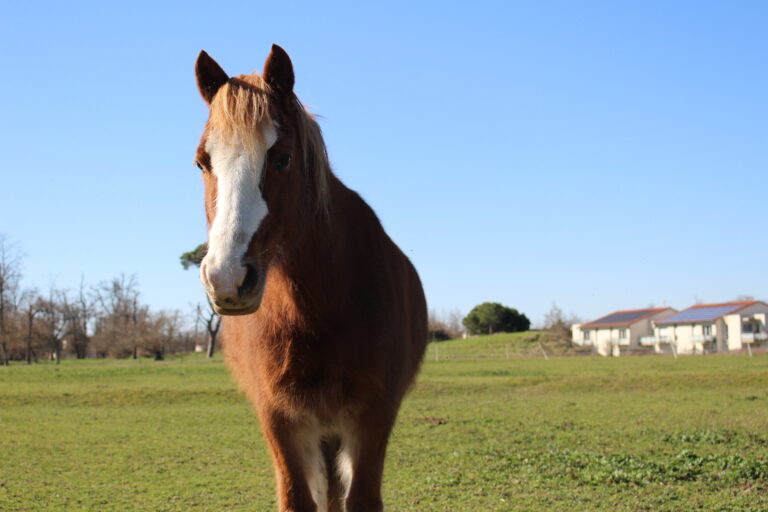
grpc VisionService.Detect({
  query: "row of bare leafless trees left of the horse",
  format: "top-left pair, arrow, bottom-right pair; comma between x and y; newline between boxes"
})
0,235 -> 208,366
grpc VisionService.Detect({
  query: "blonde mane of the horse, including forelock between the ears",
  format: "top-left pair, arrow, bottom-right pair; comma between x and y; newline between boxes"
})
208,74 -> 331,216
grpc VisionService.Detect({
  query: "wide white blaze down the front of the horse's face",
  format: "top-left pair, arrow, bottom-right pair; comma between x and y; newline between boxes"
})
201,124 -> 277,297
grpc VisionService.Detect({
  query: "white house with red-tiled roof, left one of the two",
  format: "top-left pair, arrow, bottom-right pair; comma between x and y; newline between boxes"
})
571,308 -> 677,356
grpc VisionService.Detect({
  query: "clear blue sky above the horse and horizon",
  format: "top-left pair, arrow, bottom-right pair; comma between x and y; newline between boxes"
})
0,0 -> 768,323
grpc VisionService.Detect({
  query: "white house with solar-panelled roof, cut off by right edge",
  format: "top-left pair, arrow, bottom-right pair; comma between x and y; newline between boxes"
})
640,300 -> 768,354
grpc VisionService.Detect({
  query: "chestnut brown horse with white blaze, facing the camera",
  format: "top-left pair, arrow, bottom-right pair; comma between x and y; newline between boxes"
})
196,45 -> 427,512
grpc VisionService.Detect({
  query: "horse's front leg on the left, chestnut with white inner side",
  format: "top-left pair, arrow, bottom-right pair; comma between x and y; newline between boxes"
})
260,410 -> 328,512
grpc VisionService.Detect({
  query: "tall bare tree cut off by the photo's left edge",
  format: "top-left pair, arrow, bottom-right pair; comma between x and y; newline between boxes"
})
0,235 -> 21,366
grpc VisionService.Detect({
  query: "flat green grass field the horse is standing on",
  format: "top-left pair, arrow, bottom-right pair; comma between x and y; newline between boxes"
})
0,339 -> 768,512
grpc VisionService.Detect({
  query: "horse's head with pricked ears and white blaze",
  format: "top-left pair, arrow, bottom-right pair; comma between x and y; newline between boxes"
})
195,45 -> 320,315
